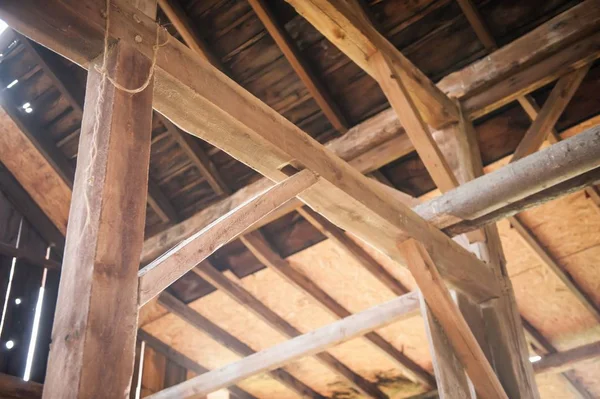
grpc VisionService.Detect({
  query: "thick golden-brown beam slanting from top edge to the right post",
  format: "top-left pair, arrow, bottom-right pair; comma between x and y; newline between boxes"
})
287,0 -> 458,129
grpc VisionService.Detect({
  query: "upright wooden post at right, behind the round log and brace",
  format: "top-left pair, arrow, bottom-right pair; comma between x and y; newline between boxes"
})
425,115 -> 539,398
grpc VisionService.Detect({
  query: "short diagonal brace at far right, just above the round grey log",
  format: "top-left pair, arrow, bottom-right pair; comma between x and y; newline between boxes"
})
511,64 -> 590,162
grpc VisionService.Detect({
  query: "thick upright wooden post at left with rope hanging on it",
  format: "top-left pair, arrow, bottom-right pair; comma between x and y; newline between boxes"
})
43,21 -> 154,398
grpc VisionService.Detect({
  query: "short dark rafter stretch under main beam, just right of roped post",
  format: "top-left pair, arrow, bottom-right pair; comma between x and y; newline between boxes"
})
156,114 -> 231,196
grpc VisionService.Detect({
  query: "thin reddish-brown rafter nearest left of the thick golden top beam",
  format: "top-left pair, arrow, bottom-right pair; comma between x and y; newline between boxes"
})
248,0 -> 348,133
